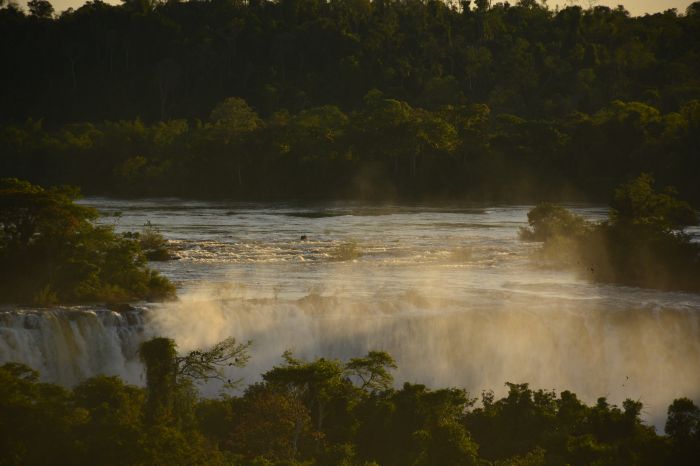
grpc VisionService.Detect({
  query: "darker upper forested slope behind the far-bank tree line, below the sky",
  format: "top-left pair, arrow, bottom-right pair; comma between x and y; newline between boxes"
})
0,0 -> 698,121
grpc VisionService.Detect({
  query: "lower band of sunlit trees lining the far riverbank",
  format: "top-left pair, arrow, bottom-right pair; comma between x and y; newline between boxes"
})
0,94 -> 700,204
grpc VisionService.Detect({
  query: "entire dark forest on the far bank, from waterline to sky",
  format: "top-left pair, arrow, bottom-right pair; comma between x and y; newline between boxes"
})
0,0 -> 700,205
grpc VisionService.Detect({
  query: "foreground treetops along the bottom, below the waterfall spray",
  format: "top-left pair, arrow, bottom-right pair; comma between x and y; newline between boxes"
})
0,338 -> 700,466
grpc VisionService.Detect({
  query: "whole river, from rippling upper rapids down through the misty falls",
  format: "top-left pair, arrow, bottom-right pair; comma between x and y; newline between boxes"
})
0,198 -> 700,425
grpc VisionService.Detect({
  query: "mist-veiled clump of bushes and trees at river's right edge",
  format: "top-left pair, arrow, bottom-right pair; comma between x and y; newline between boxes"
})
520,174 -> 700,291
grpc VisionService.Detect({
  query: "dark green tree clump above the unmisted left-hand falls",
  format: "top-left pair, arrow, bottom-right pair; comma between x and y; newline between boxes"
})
0,178 -> 175,305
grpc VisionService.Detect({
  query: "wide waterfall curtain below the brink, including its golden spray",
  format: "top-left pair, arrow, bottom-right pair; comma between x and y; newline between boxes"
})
0,289 -> 700,427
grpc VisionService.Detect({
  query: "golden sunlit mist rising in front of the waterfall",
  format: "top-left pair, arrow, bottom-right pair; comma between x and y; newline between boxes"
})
149,274 -> 700,427
